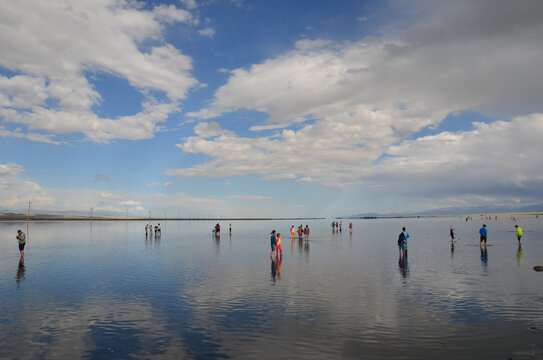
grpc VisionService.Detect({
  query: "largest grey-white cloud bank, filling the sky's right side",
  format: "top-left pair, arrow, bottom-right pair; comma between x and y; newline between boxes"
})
175,1 -> 543,208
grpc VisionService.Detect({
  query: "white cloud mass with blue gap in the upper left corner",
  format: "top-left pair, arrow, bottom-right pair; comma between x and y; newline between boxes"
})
0,0 -> 198,143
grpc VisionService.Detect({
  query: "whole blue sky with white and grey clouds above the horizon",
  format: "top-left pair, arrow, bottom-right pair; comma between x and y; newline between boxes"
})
0,0 -> 543,217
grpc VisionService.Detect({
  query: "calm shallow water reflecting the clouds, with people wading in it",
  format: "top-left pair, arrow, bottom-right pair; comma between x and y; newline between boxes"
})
0,217 -> 543,359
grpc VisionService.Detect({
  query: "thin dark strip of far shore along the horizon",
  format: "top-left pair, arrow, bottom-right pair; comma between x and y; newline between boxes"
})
0,212 -> 543,222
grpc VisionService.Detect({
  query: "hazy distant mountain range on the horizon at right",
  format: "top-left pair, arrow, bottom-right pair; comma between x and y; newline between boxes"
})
345,204 -> 543,218
